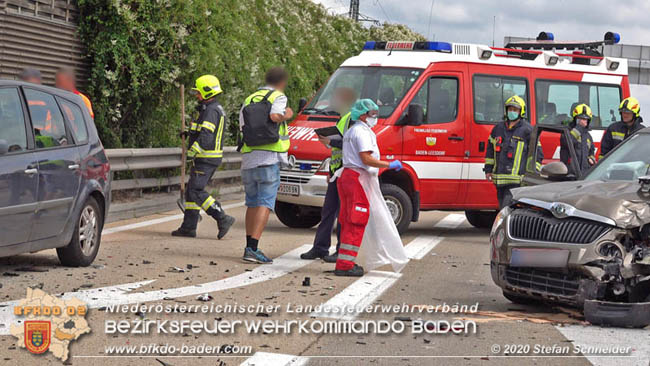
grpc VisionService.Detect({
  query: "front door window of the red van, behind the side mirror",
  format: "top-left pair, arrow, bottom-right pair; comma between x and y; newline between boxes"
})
411,77 -> 458,124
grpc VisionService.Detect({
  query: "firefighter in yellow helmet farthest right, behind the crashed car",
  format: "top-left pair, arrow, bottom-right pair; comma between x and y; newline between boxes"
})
599,97 -> 645,159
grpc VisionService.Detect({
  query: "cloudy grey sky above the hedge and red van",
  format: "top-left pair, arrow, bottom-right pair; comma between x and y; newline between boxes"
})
312,0 -> 650,46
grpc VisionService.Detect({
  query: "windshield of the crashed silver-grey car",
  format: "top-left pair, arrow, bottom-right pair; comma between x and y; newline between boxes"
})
585,133 -> 650,181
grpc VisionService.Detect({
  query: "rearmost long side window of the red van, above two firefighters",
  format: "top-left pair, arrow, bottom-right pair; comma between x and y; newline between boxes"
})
535,80 -> 621,129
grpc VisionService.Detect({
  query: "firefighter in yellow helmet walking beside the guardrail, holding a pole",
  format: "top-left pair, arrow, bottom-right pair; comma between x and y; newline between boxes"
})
172,75 -> 235,239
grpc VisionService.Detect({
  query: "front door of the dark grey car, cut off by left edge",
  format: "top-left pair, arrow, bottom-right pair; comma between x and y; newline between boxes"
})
0,88 -> 38,247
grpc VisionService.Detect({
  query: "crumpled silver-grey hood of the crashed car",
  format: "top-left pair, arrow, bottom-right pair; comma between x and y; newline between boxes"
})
512,181 -> 650,229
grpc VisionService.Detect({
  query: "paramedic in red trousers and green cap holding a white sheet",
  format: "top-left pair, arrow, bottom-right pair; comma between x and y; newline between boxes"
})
334,99 -> 408,277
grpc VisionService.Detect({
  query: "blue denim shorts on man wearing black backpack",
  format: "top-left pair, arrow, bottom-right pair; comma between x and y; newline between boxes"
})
241,164 -> 280,211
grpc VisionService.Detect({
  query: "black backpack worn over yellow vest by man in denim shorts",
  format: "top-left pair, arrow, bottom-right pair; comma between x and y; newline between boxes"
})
242,90 -> 280,146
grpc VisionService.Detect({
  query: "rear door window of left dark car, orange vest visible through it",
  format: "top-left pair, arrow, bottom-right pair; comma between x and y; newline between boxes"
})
25,88 -> 68,149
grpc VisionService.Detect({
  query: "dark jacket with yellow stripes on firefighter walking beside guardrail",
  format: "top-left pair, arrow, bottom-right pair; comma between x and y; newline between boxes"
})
187,99 -> 226,165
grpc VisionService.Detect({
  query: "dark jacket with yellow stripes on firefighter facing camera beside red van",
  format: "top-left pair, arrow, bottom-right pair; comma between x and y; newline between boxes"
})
483,119 -> 544,186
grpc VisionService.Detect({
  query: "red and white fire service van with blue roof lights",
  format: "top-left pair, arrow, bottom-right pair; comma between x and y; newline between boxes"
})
276,32 -> 629,232
